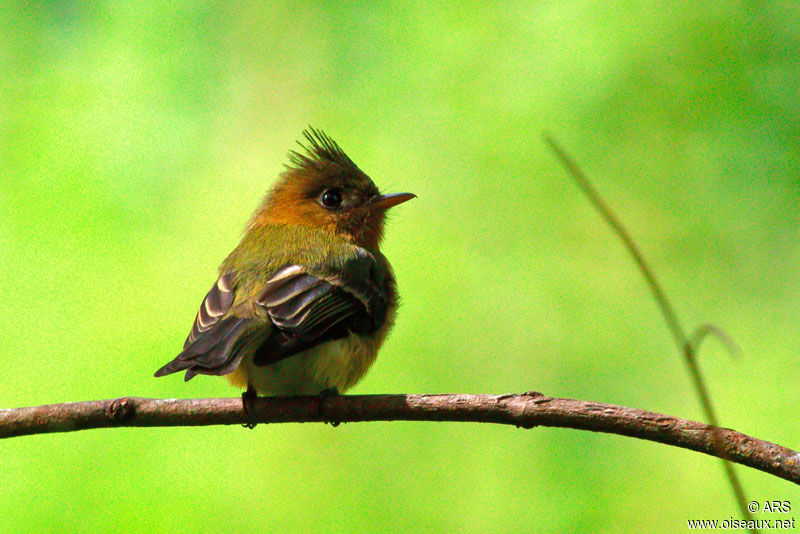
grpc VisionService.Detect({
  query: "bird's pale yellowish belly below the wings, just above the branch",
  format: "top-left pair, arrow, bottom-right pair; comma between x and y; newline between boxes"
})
228,333 -> 383,396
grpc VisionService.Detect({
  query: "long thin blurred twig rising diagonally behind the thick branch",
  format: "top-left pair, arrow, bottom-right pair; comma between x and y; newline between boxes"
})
544,135 -> 753,520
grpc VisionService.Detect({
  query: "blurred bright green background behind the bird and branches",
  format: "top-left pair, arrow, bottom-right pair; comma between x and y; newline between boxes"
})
0,1 -> 800,532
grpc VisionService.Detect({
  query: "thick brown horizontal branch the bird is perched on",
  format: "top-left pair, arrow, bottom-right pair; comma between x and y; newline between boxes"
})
0,392 -> 800,484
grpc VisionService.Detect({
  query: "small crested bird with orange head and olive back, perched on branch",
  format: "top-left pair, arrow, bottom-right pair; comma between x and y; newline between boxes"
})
155,127 -> 415,409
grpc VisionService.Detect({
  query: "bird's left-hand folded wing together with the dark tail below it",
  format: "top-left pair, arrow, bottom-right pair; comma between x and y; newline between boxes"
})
155,272 -> 252,380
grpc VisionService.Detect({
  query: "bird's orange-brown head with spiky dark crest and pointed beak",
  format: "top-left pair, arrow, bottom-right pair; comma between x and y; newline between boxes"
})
249,128 -> 415,249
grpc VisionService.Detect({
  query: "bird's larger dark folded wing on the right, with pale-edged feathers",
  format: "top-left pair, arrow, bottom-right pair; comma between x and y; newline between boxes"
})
253,251 -> 386,365
